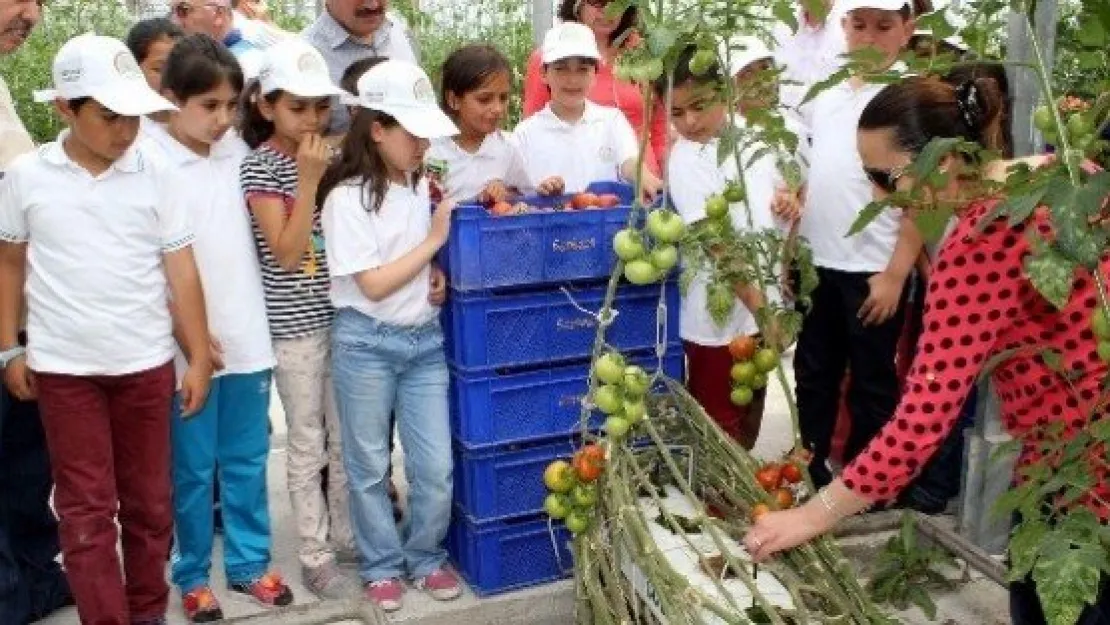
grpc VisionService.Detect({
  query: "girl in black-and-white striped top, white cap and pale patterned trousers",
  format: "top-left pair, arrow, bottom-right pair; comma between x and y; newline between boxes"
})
240,39 -> 354,598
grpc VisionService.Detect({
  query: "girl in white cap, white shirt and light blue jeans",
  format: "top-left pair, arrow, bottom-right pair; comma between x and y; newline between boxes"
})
317,60 -> 460,612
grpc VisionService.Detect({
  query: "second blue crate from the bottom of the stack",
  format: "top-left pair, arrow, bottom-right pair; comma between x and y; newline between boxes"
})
454,436 -> 577,522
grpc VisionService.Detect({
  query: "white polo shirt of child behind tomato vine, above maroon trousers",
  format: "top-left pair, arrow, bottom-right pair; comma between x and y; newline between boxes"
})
667,124 -> 787,346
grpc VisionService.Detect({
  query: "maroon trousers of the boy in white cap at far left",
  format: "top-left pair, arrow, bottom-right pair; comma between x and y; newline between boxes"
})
36,364 -> 174,625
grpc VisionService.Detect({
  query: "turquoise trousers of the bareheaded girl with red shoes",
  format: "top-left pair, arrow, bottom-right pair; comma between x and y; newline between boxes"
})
171,370 -> 272,593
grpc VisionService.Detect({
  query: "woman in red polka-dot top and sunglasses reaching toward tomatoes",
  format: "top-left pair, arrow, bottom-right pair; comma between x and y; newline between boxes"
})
745,73 -> 1110,625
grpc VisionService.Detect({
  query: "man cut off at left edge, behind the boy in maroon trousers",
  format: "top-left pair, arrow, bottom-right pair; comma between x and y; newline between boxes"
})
0,0 -> 72,625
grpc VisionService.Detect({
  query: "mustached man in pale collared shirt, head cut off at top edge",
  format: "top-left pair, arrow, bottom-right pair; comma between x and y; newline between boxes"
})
302,0 -> 420,134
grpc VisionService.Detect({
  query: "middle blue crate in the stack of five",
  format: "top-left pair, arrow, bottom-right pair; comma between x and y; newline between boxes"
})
451,350 -> 684,448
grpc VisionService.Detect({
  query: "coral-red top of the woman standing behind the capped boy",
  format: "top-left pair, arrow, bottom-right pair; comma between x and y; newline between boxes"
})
523,50 -> 667,174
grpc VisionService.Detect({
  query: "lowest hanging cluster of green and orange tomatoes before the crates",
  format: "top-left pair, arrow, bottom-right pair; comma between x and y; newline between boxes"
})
544,443 -> 605,535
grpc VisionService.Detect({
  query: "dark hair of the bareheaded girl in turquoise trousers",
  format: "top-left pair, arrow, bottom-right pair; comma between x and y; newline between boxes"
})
162,34 -> 243,101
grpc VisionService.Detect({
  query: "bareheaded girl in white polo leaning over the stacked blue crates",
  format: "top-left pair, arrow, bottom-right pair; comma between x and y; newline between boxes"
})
425,44 -> 532,203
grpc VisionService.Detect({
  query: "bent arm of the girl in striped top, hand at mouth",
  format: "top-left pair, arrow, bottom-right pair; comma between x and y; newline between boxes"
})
243,135 -> 331,271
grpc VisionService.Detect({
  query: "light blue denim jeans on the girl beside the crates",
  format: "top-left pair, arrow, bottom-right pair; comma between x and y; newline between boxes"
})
332,309 -> 452,582
